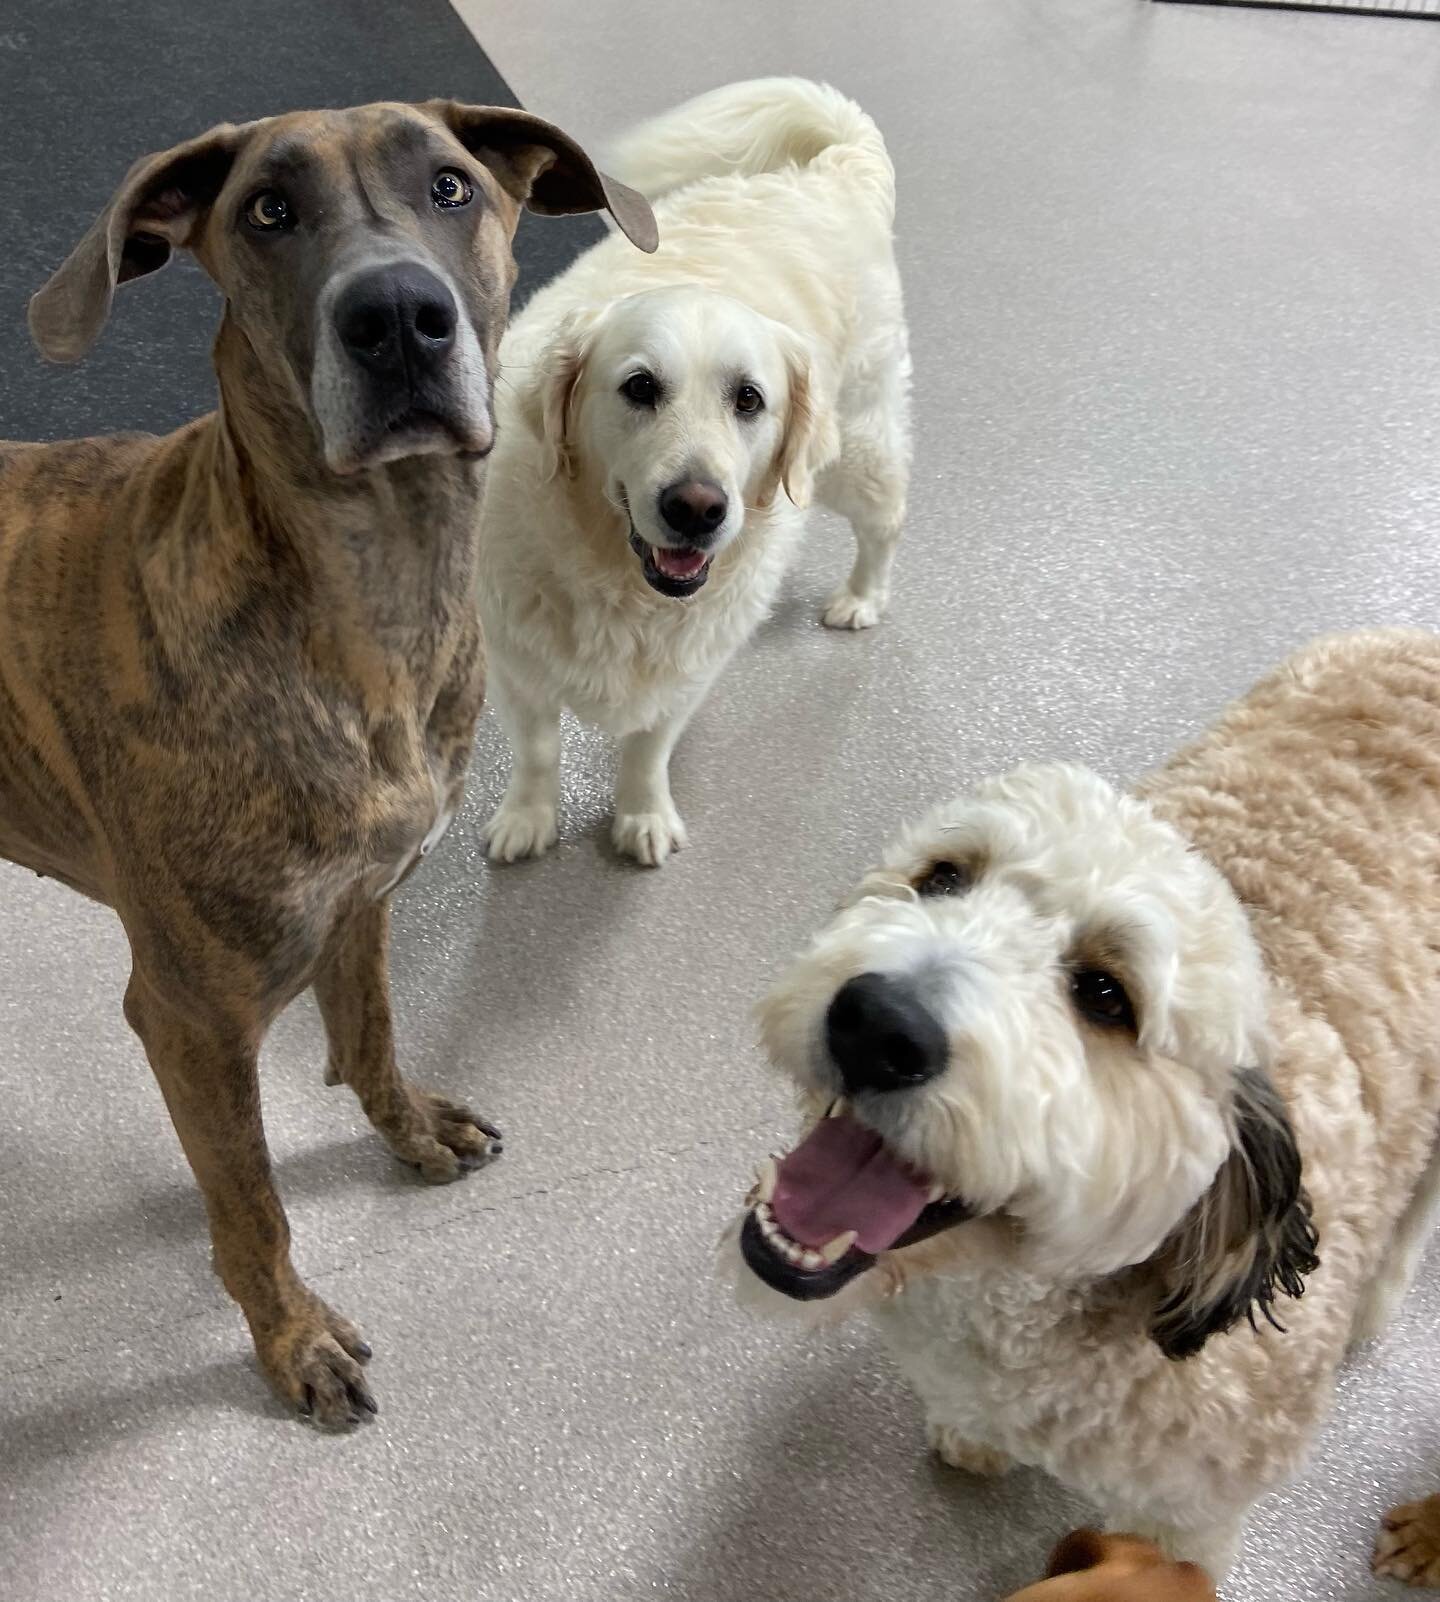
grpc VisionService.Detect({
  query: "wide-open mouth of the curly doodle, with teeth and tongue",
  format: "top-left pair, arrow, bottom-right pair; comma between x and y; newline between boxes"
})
740,1102 -> 974,1301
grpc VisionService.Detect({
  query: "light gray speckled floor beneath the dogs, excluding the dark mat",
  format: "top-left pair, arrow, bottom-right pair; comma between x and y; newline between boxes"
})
0,0 -> 1440,1602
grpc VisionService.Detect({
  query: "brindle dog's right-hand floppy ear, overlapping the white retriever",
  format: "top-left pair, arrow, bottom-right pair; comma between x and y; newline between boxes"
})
426,101 -> 660,252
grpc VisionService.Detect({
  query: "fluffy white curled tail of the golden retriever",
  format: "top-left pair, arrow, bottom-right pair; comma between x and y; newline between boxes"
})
604,78 -> 895,216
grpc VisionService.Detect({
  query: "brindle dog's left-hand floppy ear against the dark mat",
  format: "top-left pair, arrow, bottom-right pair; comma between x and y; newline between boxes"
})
30,123 -> 253,362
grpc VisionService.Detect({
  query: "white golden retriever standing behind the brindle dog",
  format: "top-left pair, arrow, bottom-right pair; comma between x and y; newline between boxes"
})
479,78 -> 910,865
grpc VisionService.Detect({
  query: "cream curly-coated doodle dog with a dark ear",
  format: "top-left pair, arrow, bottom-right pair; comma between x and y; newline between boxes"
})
727,631 -> 1440,1576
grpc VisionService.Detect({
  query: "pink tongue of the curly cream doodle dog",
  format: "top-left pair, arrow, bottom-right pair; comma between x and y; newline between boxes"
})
770,1115 -> 929,1251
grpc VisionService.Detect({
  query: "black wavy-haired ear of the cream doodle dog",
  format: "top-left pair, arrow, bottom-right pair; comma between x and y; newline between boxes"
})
1150,1069 -> 1320,1358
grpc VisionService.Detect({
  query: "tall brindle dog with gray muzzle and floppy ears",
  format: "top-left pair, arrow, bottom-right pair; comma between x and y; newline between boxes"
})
0,101 -> 655,1424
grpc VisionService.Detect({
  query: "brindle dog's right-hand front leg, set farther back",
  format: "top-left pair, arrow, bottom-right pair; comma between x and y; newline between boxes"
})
314,902 -> 501,1184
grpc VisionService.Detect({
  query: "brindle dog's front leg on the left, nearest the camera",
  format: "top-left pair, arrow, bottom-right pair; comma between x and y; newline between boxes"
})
125,971 -> 376,1426
